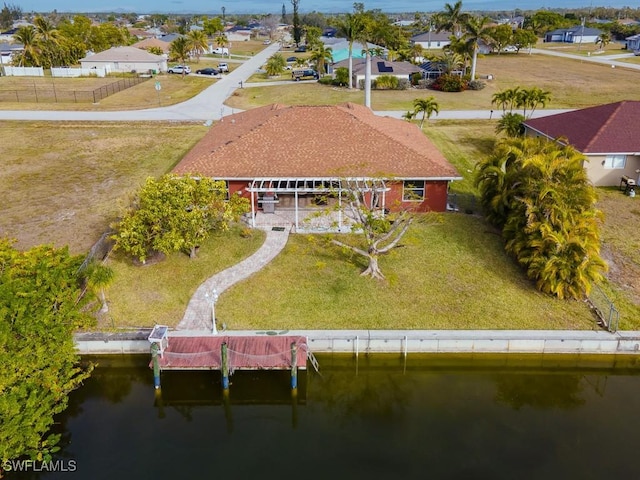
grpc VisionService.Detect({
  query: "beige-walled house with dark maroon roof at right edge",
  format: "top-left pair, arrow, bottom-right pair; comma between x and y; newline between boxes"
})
524,100 -> 640,187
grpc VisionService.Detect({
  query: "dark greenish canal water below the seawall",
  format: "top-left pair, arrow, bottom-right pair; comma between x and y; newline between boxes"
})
23,355 -> 640,480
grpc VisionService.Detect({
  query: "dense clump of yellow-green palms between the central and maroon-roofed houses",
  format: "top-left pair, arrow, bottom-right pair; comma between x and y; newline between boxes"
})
476,137 -> 606,299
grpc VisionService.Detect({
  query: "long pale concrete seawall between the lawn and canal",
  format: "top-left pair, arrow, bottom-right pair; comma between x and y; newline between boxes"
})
75,329 -> 640,355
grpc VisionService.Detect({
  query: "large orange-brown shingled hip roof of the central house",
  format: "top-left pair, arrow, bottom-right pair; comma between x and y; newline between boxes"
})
173,103 -> 459,179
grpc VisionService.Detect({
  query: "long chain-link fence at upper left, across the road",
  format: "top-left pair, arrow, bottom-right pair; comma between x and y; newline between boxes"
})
0,77 -> 149,103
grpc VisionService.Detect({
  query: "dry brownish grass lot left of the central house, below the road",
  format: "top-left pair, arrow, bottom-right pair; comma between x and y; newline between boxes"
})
0,122 -> 206,253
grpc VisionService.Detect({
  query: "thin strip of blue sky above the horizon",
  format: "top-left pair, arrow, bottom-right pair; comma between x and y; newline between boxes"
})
17,0 -> 630,15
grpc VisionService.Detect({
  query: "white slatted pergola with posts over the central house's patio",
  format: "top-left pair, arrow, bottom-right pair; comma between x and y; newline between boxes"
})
246,177 -> 390,229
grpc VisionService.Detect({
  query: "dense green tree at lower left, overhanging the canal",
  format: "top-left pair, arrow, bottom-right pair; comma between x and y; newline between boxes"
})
0,239 -> 92,464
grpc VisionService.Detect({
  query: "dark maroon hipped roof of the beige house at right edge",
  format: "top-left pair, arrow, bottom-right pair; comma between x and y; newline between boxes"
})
525,100 -> 640,154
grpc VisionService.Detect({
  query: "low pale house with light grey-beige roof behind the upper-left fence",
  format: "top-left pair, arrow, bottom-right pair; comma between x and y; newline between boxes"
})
80,47 -> 167,72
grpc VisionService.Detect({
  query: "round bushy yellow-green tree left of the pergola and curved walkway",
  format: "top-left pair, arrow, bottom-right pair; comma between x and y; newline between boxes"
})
113,174 -> 249,263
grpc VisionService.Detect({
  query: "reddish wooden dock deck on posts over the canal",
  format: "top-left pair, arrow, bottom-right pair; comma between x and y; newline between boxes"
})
152,335 -> 307,372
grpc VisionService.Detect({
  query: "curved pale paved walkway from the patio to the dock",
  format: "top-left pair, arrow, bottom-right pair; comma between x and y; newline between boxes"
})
176,228 -> 290,332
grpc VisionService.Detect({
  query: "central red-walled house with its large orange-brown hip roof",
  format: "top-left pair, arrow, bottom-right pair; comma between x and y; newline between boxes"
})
173,103 -> 461,228
